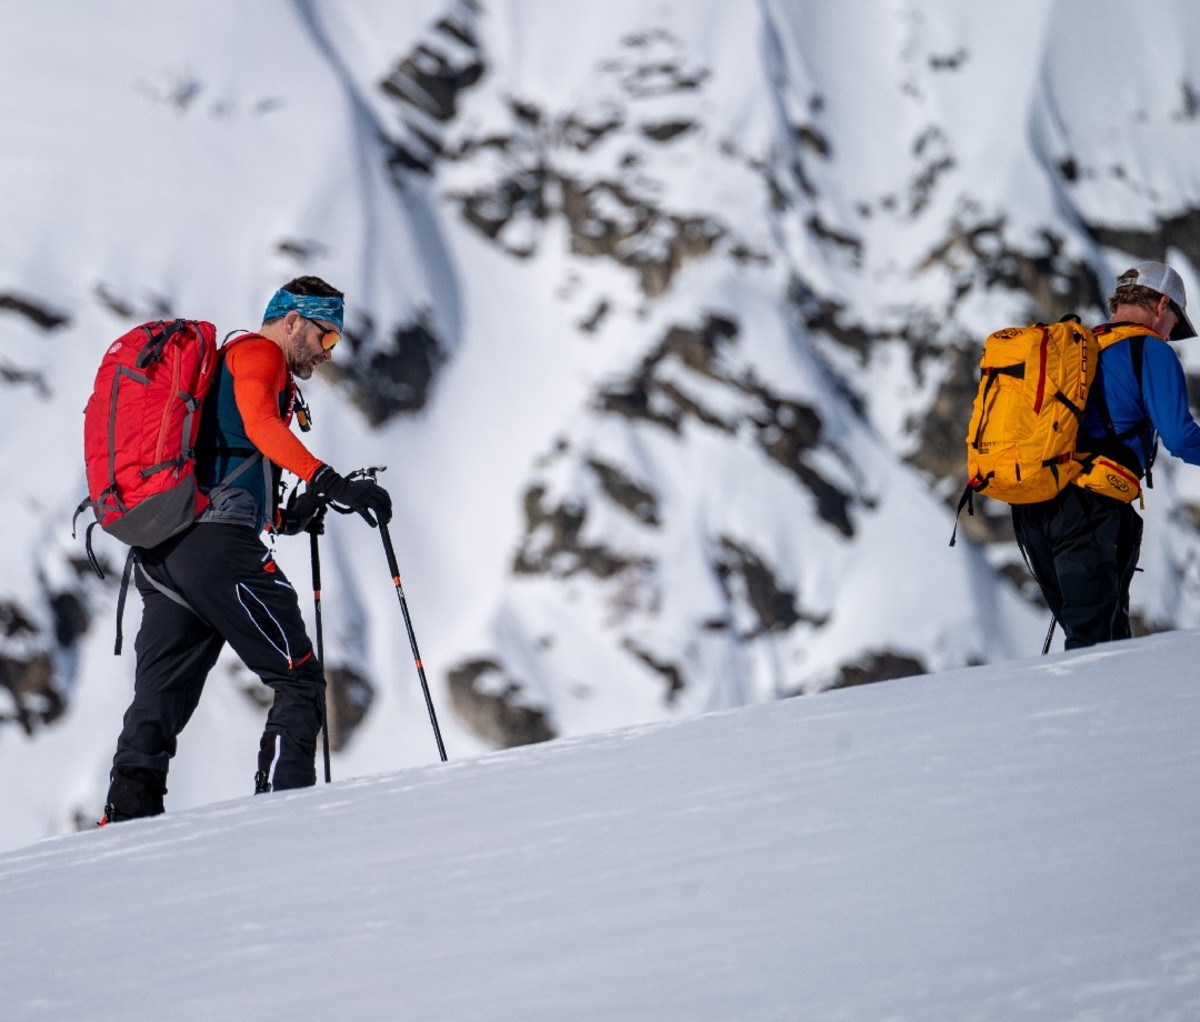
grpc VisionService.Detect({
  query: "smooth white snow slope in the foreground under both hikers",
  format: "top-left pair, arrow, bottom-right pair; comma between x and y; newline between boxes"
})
0,632 -> 1200,1022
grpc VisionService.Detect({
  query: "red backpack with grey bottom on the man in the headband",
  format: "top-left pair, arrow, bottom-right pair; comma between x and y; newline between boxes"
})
76,319 -> 218,558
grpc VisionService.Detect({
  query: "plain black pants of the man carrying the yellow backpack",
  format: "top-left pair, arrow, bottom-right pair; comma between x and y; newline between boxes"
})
1013,486 -> 1142,649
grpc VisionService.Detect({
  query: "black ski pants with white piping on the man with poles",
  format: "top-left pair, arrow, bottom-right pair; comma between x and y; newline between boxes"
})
110,523 -> 325,801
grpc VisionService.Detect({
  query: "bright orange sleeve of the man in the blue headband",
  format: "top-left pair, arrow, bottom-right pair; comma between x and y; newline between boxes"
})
226,337 -> 324,482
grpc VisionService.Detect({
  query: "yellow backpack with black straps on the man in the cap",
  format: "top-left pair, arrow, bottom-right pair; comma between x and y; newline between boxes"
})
950,315 -> 1152,546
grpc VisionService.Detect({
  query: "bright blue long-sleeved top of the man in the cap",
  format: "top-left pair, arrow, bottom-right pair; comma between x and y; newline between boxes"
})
1082,333 -> 1200,470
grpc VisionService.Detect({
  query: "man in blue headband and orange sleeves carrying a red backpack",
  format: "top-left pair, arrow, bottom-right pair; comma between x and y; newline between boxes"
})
96,277 -> 391,823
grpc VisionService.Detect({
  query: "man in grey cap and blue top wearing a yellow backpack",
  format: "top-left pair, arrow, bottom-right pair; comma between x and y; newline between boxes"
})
950,261 -> 1200,649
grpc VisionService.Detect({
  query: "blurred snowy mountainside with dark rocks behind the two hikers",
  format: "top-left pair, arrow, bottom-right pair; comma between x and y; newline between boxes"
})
0,0 -> 1200,844
